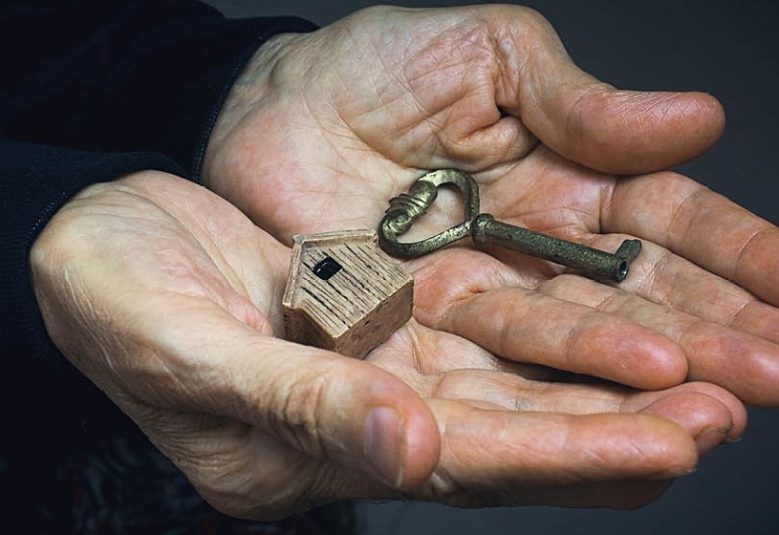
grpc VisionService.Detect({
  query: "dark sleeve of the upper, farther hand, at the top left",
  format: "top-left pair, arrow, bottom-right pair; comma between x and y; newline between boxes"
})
0,0 -> 314,176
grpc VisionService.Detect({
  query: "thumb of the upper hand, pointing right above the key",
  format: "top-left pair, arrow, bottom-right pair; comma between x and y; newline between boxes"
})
495,6 -> 725,174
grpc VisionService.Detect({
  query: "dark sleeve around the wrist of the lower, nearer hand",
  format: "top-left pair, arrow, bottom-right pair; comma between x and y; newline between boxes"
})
0,141 -> 183,436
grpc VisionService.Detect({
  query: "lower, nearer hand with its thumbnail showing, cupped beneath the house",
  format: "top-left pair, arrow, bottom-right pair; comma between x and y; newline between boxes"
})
31,172 -> 746,519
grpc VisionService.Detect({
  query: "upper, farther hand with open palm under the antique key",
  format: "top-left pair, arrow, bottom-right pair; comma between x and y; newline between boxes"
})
204,6 -> 779,406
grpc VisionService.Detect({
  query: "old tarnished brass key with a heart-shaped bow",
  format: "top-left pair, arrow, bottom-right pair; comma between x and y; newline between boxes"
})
379,169 -> 641,282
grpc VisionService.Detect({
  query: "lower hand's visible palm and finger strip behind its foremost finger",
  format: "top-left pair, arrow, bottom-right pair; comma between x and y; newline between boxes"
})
370,321 -> 747,440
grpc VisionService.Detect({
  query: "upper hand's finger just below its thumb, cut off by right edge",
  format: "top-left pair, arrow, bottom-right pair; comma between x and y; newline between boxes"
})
602,173 -> 779,305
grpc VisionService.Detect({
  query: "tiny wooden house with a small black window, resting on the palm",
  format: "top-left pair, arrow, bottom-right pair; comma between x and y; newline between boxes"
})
282,230 -> 414,358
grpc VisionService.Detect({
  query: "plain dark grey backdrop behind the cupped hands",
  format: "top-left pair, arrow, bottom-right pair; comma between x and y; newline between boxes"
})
210,0 -> 779,535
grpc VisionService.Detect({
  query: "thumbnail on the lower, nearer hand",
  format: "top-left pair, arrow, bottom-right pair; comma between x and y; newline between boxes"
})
364,407 -> 405,488
